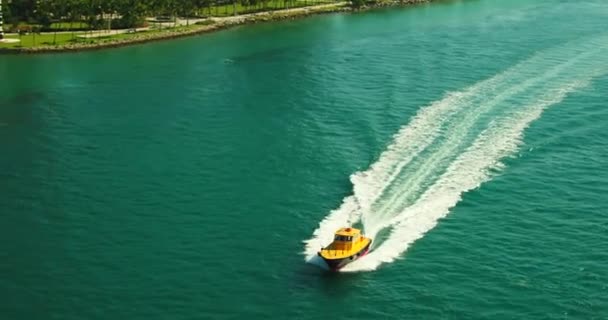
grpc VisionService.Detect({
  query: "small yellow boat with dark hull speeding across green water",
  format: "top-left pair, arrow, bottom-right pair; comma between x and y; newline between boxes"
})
318,228 -> 372,271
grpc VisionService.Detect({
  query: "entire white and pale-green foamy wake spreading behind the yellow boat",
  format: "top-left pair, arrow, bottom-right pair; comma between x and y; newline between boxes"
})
304,35 -> 608,271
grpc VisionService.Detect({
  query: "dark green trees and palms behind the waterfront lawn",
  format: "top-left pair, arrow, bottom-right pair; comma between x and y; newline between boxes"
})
2,0 -> 336,32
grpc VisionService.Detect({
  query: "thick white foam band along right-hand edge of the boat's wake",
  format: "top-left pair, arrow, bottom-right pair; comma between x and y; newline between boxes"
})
344,82 -> 585,271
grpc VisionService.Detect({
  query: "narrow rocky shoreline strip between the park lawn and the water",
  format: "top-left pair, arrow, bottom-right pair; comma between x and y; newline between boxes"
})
0,0 -> 430,55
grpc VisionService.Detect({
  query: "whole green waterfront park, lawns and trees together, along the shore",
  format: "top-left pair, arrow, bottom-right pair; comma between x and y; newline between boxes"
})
0,0 -> 352,51
